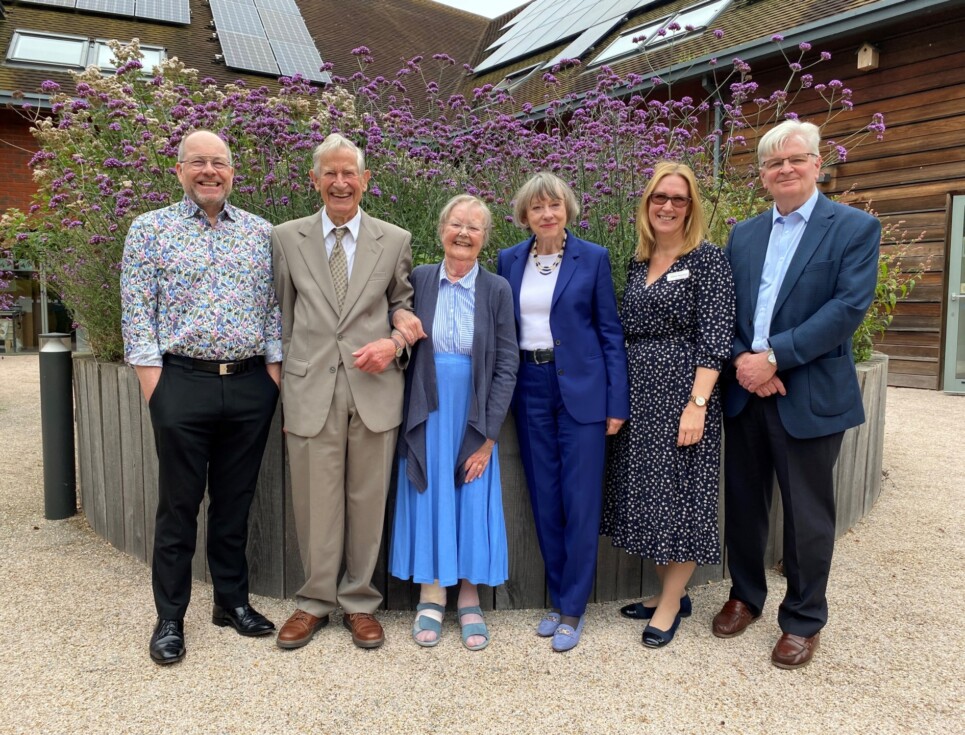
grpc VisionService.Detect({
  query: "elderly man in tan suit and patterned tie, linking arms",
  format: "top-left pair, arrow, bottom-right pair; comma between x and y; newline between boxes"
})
272,133 -> 422,648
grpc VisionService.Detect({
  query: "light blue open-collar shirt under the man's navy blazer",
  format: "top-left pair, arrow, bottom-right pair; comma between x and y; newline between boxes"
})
751,189 -> 818,352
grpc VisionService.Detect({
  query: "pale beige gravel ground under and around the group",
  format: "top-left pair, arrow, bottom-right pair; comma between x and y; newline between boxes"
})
0,355 -> 965,735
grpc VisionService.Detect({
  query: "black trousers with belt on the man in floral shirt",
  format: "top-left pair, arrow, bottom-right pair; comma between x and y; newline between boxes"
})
150,363 -> 278,620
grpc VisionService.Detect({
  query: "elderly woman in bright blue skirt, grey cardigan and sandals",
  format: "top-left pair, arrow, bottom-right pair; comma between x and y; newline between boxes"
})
389,195 -> 519,651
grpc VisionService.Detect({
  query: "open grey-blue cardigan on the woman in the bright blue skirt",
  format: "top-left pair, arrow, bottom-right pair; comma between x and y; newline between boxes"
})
399,263 -> 519,492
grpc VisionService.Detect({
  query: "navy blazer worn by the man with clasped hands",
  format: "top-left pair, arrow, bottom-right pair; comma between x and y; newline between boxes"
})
724,194 -> 881,439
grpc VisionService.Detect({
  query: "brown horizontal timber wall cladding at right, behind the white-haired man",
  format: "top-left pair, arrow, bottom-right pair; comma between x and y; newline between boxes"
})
739,10 -> 965,389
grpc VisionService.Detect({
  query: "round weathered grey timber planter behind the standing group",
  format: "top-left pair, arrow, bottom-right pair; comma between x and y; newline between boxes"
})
74,354 -> 888,609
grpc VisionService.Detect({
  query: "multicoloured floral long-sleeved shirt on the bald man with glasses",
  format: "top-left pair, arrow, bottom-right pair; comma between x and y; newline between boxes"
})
121,197 -> 281,367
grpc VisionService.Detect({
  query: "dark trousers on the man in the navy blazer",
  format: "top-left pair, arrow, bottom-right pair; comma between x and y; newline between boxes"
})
724,396 -> 844,637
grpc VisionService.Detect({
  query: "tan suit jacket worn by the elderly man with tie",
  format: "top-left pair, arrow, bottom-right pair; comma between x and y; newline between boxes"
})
272,207 -> 412,437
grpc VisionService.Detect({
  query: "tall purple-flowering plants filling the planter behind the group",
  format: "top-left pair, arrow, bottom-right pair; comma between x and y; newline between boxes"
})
0,37 -> 884,359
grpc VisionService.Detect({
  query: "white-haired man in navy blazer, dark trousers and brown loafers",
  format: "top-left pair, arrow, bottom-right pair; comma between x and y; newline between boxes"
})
713,120 -> 881,669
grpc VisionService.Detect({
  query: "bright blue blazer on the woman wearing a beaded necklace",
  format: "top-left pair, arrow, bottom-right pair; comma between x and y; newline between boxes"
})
498,231 -> 630,424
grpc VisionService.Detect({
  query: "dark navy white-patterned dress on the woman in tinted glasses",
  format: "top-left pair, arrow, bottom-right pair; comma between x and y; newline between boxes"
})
600,242 -> 734,564
